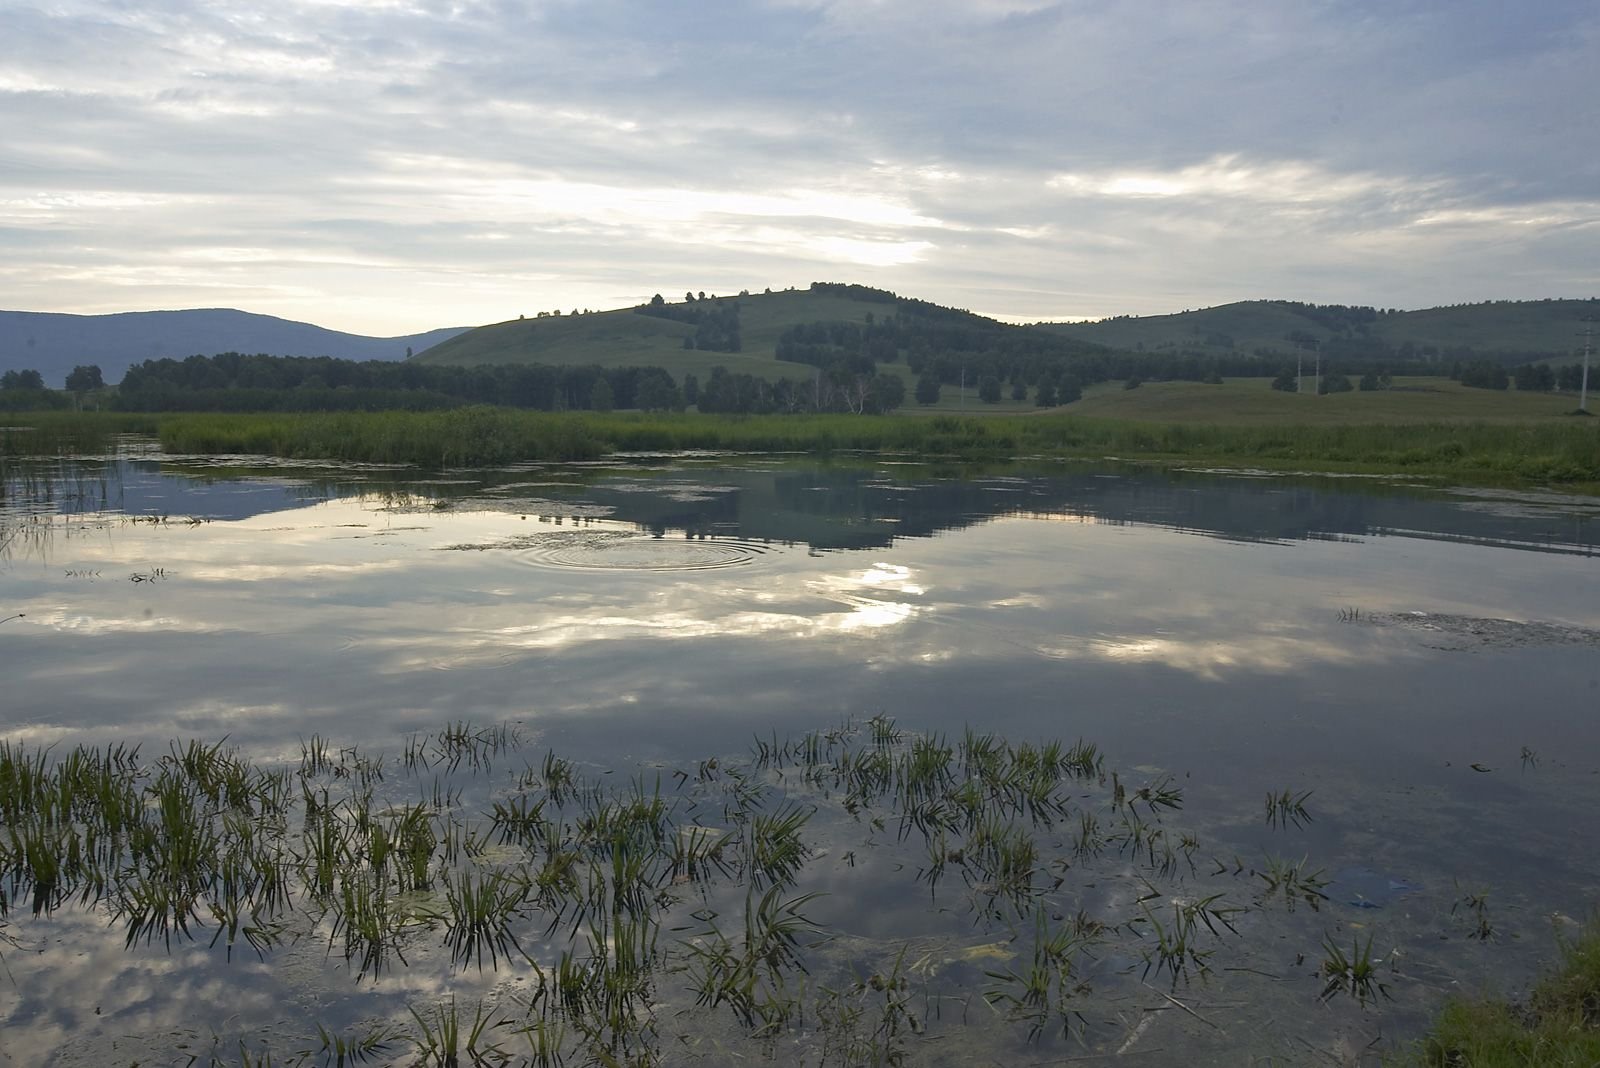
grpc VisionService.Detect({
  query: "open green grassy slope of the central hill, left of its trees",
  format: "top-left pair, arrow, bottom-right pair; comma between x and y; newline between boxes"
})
414,289 -> 893,381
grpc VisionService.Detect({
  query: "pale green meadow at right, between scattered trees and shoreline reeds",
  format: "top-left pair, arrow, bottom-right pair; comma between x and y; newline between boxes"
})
1056,376 -> 1576,427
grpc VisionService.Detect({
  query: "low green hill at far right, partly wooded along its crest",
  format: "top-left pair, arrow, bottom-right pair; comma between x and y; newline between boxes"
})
1035,301 -> 1600,361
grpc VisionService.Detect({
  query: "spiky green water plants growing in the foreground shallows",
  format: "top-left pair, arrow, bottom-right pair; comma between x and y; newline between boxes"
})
0,716 -> 1574,1065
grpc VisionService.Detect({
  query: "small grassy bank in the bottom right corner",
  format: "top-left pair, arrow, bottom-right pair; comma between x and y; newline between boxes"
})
1395,923 -> 1600,1068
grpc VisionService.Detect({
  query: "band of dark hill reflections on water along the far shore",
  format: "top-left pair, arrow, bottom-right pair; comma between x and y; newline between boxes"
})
9,447 -> 1600,555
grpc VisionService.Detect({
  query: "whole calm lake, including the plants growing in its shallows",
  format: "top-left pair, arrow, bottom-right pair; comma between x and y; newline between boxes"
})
0,441 -> 1600,1065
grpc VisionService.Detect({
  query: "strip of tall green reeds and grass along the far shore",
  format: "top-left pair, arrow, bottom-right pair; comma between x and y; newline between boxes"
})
5,408 -> 1600,491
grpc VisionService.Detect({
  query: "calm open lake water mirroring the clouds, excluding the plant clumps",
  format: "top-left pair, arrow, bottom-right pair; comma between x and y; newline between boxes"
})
0,451 -> 1600,1065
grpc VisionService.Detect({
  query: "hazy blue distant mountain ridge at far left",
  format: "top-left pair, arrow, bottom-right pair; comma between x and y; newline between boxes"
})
0,309 -> 469,387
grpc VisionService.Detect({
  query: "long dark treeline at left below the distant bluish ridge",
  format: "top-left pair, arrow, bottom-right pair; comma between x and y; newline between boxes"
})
115,352 -> 686,411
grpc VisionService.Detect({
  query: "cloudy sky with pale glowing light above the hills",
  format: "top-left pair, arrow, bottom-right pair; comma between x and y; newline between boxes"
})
0,0 -> 1600,336
